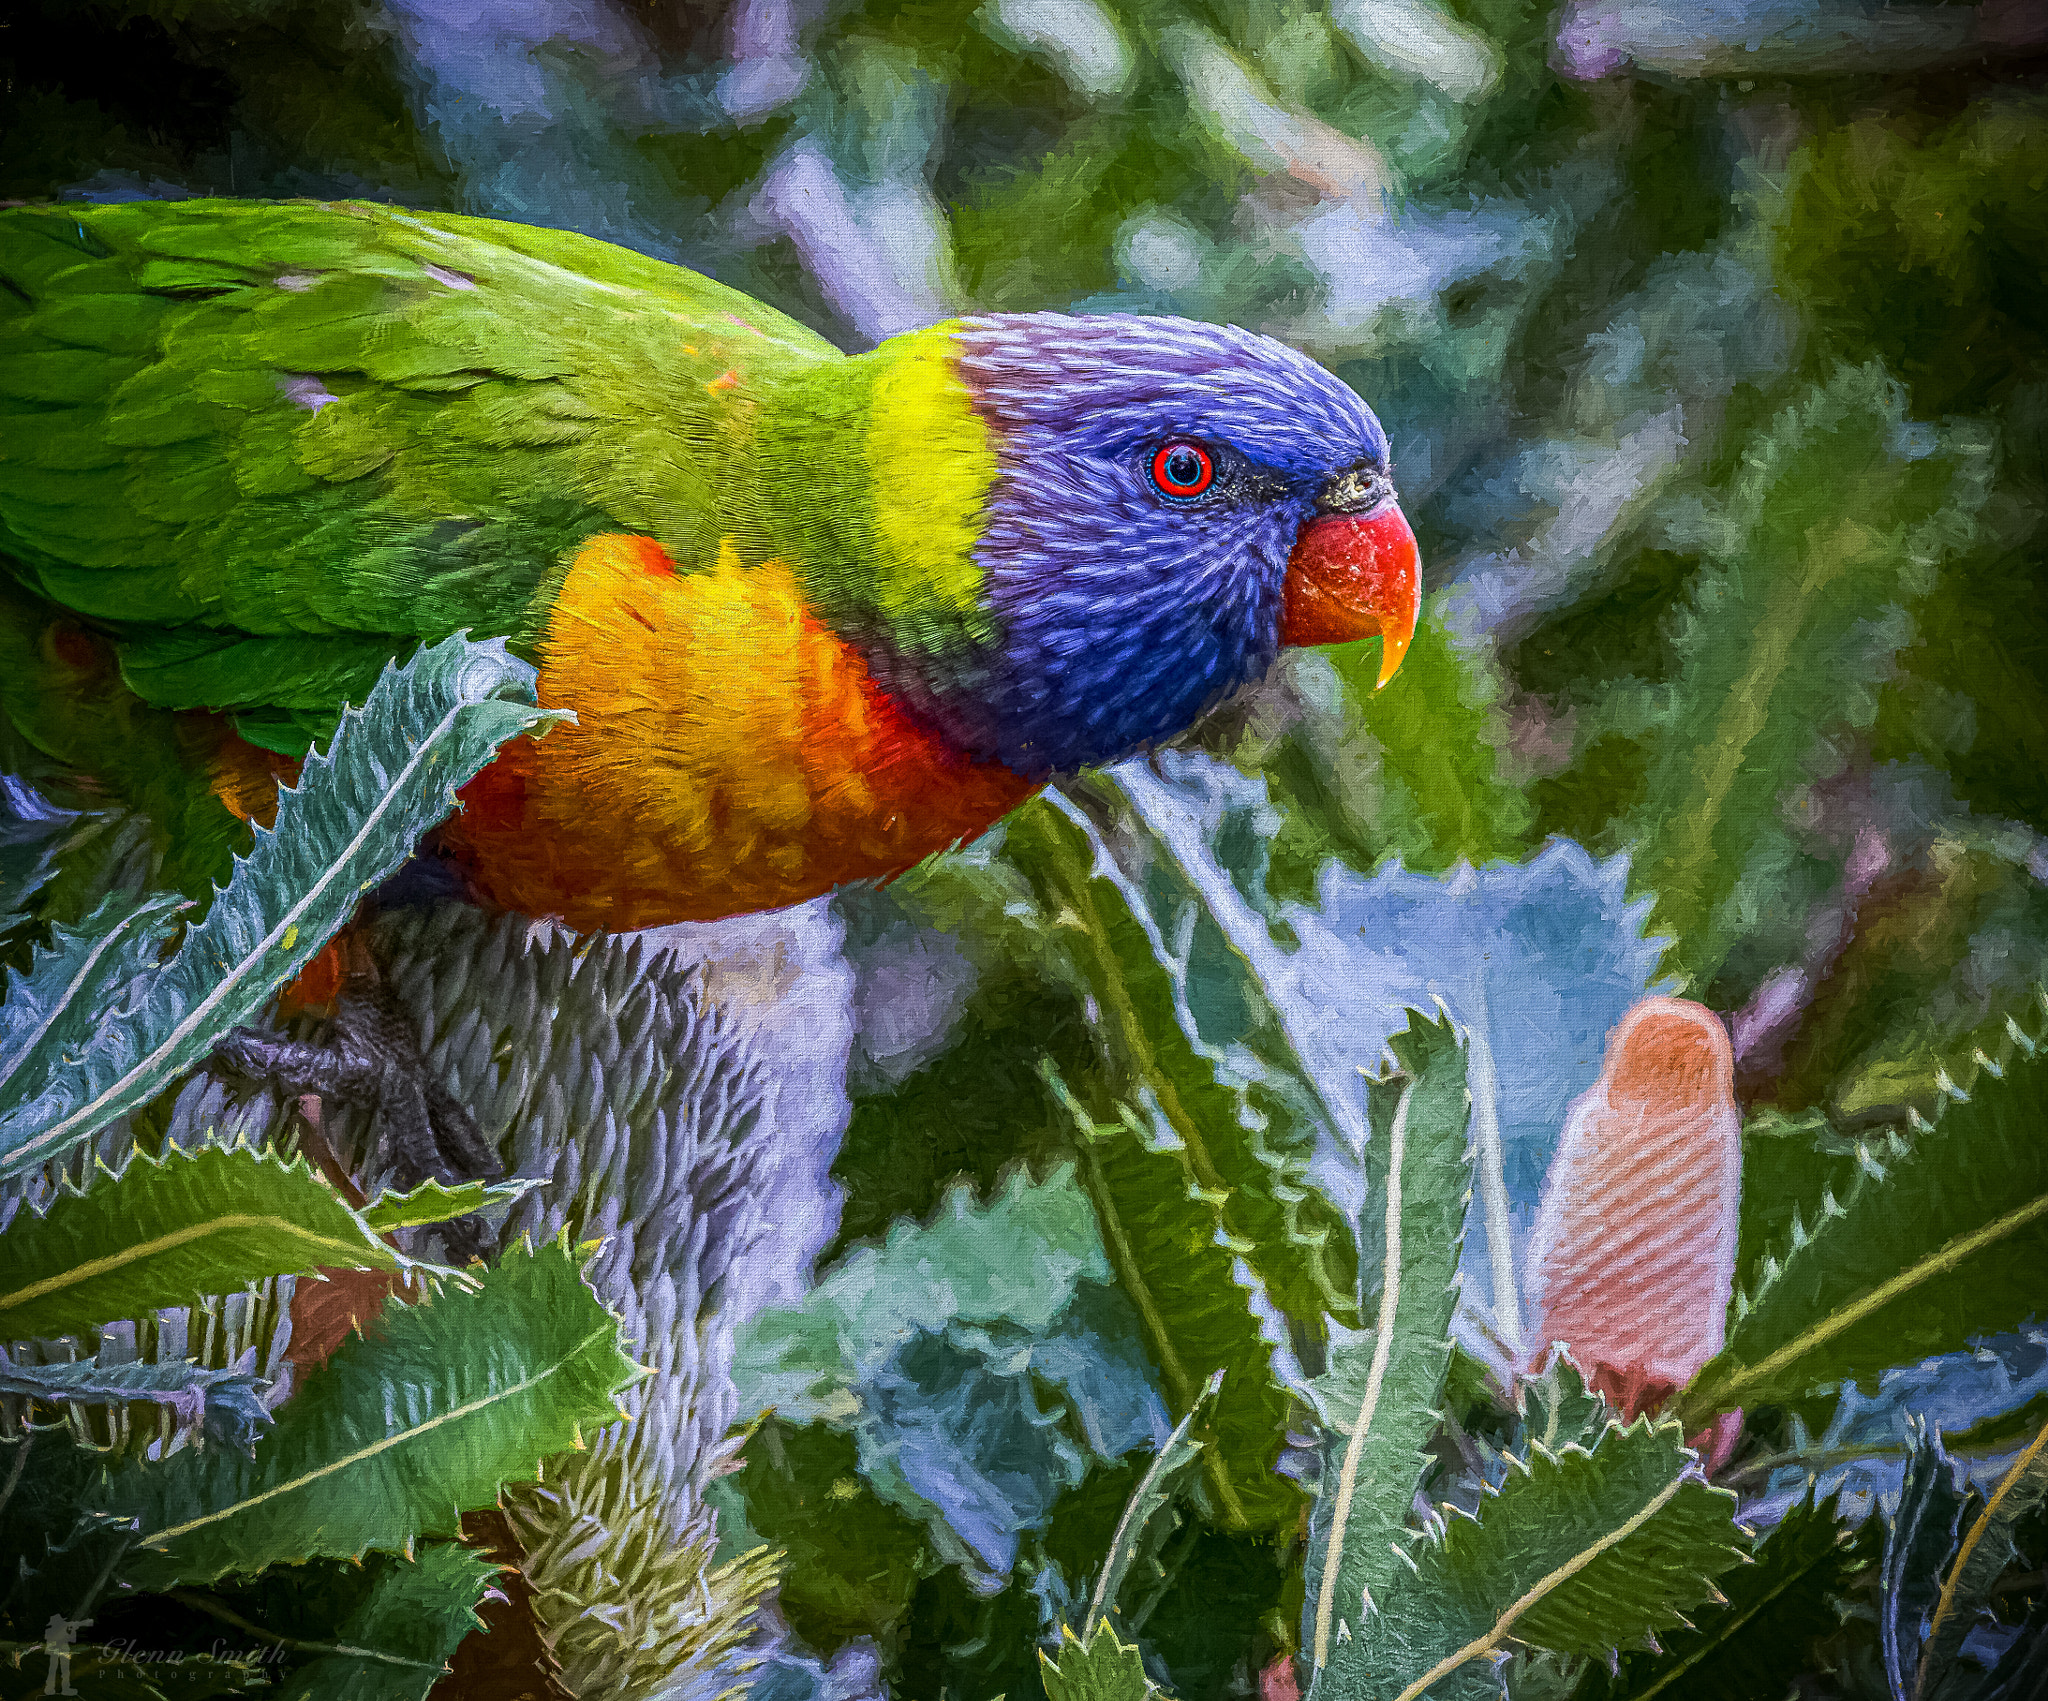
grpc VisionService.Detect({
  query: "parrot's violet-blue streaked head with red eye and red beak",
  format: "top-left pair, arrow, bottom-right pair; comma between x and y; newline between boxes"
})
856,313 -> 1415,776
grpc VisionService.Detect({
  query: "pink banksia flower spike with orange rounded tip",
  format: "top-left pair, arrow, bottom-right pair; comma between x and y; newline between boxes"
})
1526,997 -> 1743,1451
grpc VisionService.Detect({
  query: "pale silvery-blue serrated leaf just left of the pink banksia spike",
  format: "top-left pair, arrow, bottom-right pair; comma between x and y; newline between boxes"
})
1116,751 -> 1663,1382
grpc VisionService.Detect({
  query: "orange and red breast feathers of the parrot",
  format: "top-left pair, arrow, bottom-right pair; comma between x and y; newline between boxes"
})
442,536 -> 1036,931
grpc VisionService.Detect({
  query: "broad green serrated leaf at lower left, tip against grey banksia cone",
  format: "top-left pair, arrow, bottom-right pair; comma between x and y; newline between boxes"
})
94,1242 -> 635,1588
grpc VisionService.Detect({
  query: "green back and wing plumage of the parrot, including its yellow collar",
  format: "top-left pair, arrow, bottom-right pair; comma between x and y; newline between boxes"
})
0,201 -> 995,890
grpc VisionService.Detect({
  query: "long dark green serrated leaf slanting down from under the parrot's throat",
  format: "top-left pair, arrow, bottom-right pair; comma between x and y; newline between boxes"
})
1004,780 -> 1354,1320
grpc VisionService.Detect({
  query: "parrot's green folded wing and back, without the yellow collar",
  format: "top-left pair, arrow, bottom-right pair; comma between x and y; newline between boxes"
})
0,201 -> 836,755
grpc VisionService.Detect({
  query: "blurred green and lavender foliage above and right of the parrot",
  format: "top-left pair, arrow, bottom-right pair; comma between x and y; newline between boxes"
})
0,0 -> 2048,1120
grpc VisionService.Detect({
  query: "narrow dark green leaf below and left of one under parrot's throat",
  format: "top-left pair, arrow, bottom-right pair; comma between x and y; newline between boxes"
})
1047,1066 -> 1300,1529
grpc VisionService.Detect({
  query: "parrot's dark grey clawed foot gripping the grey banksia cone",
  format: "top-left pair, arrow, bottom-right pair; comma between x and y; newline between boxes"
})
217,942 -> 504,1259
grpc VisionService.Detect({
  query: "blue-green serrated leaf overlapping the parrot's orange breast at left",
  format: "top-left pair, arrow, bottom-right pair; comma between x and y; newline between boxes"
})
0,637 -> 559,1175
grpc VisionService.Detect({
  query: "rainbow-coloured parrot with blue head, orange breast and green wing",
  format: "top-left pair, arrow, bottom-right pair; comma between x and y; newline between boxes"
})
0,201 -> 1421,1203
